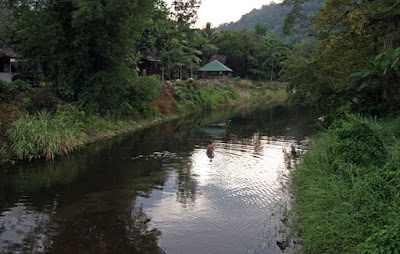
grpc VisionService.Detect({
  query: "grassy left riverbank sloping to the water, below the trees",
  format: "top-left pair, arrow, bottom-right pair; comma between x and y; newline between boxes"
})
0,80 -> 286,163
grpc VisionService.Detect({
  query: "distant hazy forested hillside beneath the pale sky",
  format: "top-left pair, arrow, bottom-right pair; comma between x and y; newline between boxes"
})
218,0 -> 326,42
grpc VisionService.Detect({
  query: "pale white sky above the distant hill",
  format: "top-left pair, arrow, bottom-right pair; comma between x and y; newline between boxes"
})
165,0 -> 282,28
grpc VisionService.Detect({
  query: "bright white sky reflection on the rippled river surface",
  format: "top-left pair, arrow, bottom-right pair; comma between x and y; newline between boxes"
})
139,138 -> 296,253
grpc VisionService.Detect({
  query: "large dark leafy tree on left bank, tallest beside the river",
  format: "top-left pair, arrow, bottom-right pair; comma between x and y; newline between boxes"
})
8,0 -> 154,112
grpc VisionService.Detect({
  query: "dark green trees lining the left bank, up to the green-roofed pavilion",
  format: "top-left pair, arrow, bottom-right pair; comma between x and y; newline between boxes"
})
0,0 -> 293,118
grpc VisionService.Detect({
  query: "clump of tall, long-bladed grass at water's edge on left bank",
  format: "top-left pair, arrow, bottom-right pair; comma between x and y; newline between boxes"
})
8,110 -> 83,160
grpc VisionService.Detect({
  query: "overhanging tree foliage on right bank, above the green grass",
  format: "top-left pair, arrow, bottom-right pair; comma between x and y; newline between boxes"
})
282,0 -> 400,115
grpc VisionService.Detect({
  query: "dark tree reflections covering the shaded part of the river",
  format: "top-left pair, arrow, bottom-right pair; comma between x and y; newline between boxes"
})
0,102 -> 316,253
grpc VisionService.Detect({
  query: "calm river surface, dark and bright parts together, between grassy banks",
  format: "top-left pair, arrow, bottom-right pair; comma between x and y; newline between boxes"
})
0,106 -> 313,253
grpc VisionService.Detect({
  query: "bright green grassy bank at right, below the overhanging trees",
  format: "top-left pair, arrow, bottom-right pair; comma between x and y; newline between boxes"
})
292,116 -> 400,253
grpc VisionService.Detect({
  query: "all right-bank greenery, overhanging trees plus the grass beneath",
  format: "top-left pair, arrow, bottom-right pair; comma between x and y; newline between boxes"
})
280,0 -> 400,253
